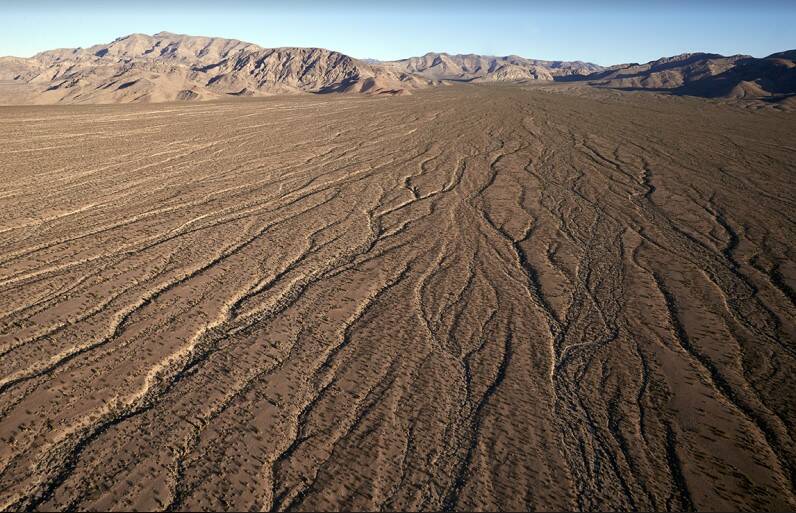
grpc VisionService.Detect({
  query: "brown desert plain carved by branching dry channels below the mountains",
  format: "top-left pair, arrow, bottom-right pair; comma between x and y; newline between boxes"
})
0,85 -> 796,511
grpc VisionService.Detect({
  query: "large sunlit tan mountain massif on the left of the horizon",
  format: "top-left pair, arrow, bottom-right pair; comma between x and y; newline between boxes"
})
0,31 -> 426,103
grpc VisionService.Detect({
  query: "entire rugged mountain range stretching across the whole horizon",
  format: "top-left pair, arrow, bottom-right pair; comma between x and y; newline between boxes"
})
0,32 -> 796,104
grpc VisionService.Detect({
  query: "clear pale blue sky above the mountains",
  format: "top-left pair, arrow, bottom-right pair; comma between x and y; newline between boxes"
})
0,0 -> 796,65
